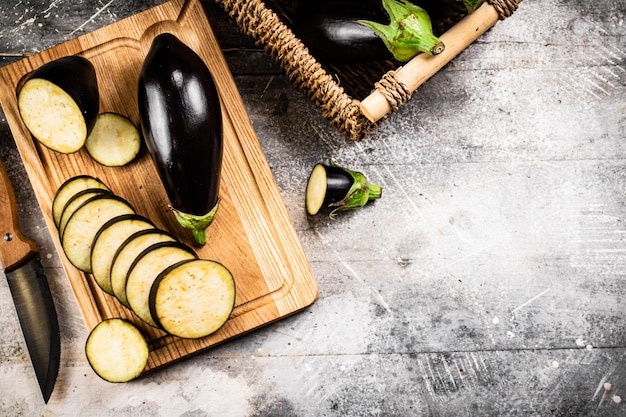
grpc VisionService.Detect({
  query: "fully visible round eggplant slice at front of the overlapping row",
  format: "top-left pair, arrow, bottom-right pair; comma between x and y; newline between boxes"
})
150,259 -> 235,339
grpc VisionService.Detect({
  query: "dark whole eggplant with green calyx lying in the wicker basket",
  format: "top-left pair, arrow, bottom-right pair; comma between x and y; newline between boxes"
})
292,0 -> 445,63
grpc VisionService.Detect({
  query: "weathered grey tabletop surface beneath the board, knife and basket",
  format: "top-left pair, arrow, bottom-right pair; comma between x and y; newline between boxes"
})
0,0 -> 626,417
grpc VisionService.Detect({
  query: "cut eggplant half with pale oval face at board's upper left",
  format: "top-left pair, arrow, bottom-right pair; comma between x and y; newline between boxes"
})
17,55 -> 100,153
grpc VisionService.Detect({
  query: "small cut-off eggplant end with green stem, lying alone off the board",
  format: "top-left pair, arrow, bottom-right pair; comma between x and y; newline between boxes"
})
306,164 -> 382,217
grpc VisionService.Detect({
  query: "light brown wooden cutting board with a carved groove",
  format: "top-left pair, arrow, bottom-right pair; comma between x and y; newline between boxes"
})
0,0 -> 317,372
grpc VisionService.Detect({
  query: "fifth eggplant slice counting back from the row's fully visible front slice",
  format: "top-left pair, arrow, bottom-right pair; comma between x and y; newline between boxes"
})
61,194 -> 135,273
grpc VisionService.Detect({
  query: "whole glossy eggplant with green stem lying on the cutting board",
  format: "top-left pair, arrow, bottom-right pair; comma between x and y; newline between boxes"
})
138,33 -> 223,245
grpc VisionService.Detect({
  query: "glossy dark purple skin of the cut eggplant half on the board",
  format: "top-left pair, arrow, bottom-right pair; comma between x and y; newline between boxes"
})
28,55 -> 100,134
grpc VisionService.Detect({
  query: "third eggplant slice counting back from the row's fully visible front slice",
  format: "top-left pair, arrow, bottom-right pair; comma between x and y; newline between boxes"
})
111,229 -> 176,308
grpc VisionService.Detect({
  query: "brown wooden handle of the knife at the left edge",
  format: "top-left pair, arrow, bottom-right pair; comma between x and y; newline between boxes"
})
0,161 -> 37,272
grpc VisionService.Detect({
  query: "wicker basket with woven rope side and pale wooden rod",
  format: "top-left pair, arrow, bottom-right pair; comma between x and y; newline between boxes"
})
215,0 -> 521,140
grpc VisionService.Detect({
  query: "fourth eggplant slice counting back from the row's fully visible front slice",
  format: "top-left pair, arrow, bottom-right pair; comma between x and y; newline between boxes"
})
91,214 -> 155,295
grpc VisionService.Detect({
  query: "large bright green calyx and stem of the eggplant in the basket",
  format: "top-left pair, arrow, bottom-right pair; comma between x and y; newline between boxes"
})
358,0 -> 445,62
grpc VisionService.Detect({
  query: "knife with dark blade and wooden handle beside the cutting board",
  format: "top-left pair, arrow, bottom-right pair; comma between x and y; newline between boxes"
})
0,158 -> 61,403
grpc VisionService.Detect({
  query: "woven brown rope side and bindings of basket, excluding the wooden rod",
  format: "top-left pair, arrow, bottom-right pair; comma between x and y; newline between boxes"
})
215,0 -> 521,140
